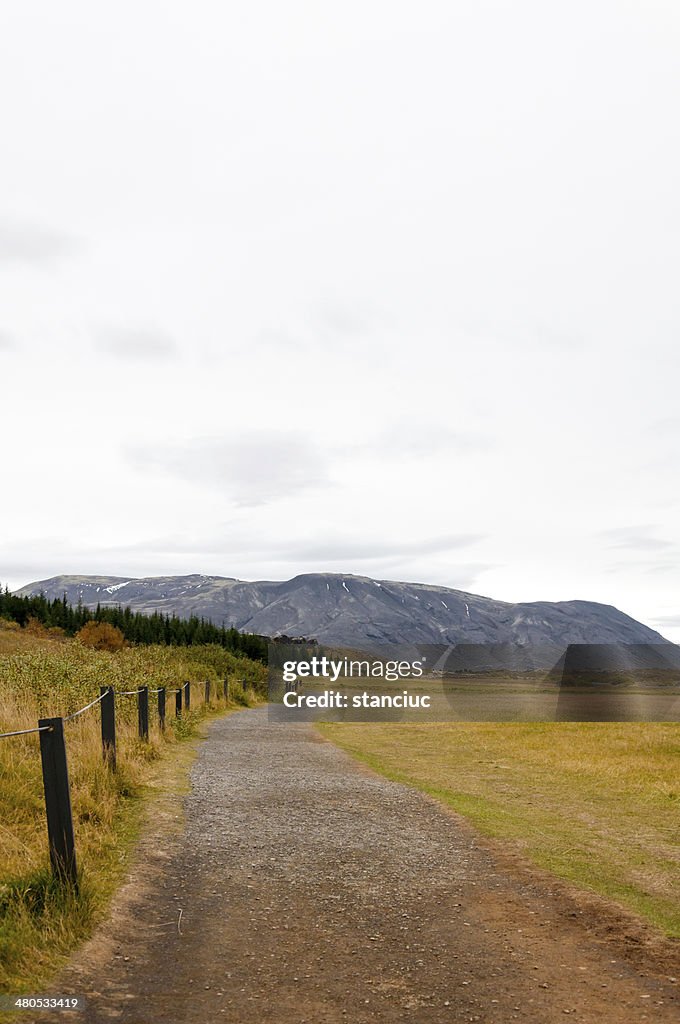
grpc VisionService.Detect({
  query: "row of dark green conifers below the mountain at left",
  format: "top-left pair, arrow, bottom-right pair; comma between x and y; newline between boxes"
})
0,588 -> 268,665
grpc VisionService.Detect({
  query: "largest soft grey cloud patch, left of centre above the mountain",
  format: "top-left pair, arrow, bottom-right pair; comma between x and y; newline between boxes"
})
126,431 -> 329,506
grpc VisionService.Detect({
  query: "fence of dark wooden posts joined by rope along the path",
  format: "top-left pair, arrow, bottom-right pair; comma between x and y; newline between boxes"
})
0,679 -> 246,892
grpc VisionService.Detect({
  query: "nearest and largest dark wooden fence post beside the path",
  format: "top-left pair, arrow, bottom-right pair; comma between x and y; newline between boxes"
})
38,701 -> 77,890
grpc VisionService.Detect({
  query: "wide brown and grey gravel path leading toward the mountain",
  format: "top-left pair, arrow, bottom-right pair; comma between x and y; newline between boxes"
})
50,709 -> 680,1024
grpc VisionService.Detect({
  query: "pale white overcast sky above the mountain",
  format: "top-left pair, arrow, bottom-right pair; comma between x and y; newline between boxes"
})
0,0 -> 680,640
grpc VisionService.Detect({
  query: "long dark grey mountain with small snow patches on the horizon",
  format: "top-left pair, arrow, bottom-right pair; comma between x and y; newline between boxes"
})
17,572 -> 669,648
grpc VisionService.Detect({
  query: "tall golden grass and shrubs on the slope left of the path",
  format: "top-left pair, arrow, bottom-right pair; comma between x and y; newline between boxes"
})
0,625 -> 265,993
